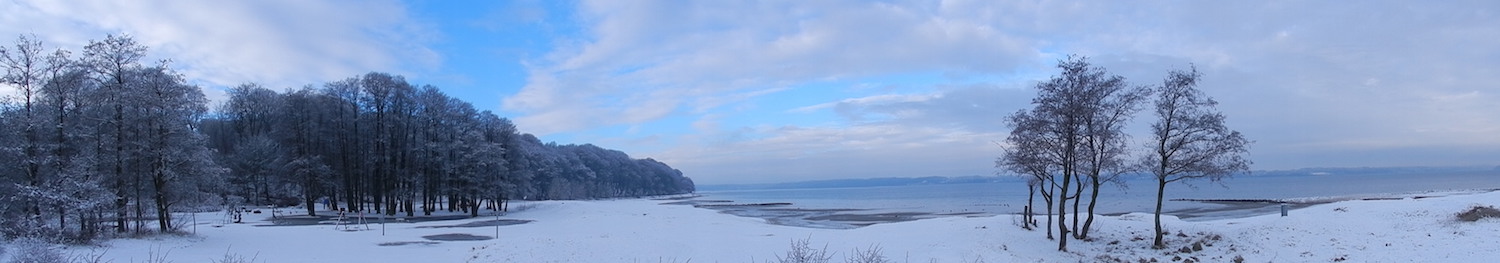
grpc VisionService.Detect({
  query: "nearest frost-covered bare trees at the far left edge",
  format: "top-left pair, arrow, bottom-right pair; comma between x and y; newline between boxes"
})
0,36 -> 226,240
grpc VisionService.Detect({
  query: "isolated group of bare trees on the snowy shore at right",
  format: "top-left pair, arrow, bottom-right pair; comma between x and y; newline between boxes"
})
996,56 -> 1250,251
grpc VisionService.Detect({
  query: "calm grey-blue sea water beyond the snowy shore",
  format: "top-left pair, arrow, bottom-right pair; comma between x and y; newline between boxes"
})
702,171 -> 1500,219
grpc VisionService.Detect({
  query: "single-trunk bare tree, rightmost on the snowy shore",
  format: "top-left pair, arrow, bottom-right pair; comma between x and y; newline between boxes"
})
1142,68 -> 1251,249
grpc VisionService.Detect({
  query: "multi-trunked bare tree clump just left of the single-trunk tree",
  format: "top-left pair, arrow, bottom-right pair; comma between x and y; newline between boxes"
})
999,57 -> 1149,251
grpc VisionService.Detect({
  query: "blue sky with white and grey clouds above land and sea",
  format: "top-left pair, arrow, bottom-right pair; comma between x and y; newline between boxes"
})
0,0 -> 1500,185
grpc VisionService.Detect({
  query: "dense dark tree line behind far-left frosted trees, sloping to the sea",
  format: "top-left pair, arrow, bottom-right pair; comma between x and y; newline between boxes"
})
203,72 -> 693,216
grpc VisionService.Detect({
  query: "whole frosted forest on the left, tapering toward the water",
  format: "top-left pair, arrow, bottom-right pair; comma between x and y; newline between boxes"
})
0,35 -> 695,242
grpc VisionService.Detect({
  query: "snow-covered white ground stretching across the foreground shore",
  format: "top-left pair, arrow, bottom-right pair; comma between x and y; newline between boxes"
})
43,192 -> 1500,263
